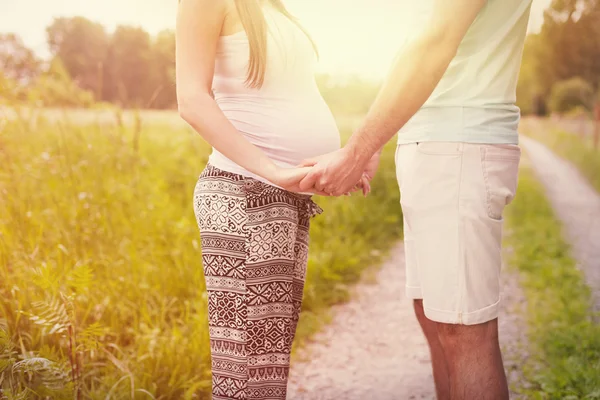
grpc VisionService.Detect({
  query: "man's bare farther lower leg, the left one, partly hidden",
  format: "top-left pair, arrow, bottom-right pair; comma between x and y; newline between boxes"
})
414,300 -> 451,400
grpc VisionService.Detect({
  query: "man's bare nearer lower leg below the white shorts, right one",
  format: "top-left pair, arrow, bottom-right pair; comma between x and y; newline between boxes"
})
436,319 -> 508,400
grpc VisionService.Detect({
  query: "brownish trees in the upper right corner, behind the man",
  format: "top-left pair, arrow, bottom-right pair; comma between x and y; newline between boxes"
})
517,0 -> 600,115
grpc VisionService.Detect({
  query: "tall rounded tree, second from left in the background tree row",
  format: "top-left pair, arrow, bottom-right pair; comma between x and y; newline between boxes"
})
46,17 -> 108,97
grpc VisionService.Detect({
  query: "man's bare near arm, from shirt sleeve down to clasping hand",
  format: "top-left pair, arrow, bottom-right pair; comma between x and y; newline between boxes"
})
300,0 -> 486,195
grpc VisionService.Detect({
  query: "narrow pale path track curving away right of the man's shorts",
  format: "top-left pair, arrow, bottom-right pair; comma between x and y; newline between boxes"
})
521,137 -> 600,311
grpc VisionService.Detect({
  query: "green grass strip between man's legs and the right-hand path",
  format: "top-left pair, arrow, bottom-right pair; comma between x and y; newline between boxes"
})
507,159 -> 600,400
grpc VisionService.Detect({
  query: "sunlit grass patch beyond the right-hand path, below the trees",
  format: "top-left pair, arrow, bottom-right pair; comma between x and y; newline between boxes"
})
525,121 -> 600,191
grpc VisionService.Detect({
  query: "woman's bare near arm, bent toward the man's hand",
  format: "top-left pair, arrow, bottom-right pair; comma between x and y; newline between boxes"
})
176,0 -> 310,191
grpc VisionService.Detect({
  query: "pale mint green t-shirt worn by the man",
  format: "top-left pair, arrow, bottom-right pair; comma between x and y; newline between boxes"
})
398,0 -> 532,144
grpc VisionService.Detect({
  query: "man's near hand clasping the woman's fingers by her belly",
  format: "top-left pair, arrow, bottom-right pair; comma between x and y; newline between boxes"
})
299,148 -> 369,196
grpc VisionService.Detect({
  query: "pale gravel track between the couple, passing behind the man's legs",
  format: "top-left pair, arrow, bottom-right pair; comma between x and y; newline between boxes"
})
288,243 -> 521,400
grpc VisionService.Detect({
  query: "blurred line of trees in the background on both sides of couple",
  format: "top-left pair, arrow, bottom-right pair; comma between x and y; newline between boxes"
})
0,0 -> 600,115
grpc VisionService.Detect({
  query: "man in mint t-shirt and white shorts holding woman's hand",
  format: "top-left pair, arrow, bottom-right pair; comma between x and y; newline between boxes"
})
300,0 -> 531,400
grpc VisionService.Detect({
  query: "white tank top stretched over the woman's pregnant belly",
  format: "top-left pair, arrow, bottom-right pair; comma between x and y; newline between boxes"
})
209,7 -> 340,182
